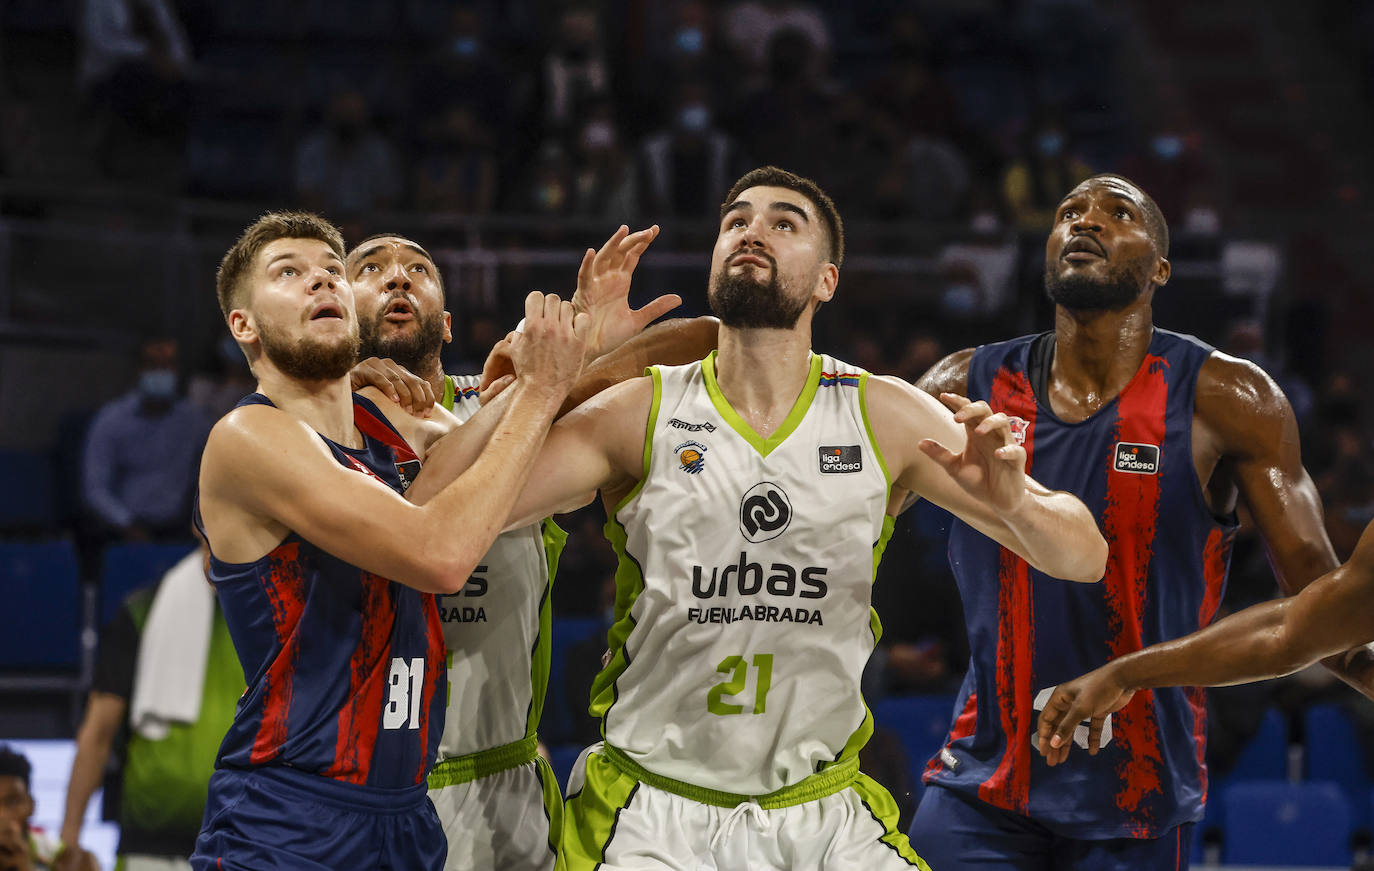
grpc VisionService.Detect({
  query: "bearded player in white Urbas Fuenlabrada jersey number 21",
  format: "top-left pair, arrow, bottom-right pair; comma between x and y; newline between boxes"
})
406,168 -> 1106,871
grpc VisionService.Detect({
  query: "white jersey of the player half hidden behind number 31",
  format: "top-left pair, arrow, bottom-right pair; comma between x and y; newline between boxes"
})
438,375 -> 566,760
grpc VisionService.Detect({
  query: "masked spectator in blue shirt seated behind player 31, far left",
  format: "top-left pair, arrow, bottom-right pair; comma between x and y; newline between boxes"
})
81,338 -> 210,540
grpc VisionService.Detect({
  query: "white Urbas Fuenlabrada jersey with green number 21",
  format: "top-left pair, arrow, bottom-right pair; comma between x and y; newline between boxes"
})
592,353 -> 892,794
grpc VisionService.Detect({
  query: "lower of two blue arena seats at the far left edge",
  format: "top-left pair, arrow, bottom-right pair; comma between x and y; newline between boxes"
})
0,539 -> 81,669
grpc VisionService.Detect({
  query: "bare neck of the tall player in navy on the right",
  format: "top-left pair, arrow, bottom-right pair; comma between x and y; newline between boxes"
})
1050,301 -> 1154,401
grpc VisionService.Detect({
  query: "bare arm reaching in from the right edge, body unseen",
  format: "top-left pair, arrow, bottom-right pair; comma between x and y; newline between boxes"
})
1039,523 -> 1374,765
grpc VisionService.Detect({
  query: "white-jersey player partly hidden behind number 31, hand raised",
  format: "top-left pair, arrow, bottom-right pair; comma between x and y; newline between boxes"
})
346,227 -> 716,871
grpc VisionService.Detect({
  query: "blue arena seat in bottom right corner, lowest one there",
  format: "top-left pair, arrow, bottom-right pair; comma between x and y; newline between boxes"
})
1221,780 -> 1351,867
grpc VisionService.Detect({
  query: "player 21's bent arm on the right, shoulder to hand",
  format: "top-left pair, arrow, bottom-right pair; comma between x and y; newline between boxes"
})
868,378 -> 1107,582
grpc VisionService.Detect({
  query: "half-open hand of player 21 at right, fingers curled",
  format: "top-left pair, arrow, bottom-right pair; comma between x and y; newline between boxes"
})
918,393 -> 1026,514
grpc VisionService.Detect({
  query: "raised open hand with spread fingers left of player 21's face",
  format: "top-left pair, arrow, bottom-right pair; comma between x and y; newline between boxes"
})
573,224 -> 683,359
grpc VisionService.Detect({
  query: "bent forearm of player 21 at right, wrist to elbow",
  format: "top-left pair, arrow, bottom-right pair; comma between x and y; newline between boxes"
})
1002,492 -> 1107,582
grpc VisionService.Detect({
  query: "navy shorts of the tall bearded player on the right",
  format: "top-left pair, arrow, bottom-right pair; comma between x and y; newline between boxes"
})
910,783 -> 1194,871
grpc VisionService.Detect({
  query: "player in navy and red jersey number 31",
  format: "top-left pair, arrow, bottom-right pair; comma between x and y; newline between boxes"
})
191,213 -> 585,871
